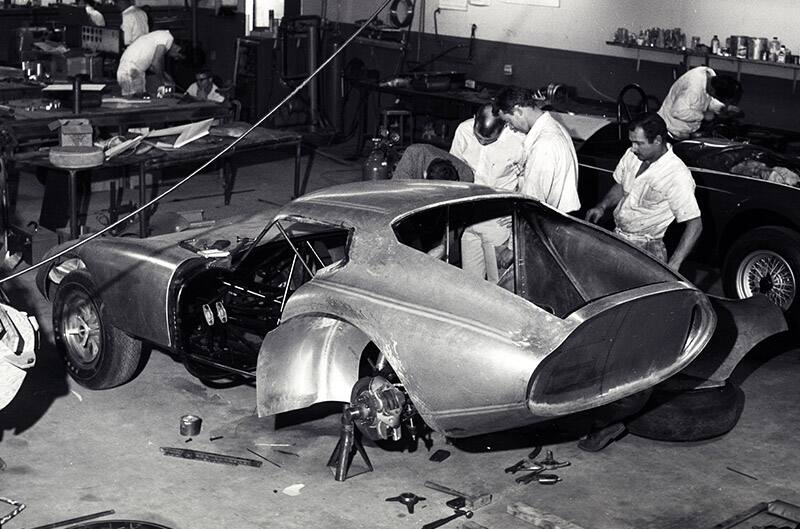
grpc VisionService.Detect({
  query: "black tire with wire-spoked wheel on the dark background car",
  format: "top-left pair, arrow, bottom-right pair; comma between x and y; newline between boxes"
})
722,226 -> 800,327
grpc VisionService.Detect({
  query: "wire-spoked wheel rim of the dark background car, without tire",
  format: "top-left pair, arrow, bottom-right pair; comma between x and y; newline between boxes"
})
736,250 -> 797,310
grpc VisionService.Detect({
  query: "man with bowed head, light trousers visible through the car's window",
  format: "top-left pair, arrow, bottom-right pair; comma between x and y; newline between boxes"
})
450,103 -> 523,282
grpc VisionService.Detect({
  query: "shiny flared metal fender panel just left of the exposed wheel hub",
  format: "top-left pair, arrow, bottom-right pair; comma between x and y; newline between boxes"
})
256,315 -> 380,416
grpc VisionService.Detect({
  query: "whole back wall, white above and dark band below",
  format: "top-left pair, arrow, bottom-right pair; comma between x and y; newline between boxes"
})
328,0 -> 800,130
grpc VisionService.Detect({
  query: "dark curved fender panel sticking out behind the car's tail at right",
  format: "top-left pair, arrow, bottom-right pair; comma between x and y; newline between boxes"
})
681,295 -> 788,387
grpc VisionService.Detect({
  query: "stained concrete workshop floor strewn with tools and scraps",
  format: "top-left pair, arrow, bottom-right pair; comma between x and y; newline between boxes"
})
0,143 -> 800,529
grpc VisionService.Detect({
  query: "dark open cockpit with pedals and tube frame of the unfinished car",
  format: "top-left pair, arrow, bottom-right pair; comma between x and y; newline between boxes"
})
176,230 -> 349,380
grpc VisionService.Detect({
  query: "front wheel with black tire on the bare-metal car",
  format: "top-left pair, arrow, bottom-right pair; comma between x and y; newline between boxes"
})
53,270 -> 142,389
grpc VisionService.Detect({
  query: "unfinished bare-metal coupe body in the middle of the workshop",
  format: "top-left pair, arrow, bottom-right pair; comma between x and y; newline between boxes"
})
38,181 -> 780,437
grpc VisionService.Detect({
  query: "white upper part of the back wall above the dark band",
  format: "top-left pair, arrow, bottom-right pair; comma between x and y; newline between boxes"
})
328,0 -> 800,60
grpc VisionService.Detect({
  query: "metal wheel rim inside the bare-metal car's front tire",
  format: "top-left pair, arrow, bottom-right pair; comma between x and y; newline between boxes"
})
60,289 -> 102,368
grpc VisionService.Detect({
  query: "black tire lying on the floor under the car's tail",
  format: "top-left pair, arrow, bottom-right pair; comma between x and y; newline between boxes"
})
626,381 -> 744,441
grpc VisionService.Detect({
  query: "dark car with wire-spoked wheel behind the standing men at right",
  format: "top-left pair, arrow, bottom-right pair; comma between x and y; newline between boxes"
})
577,123 -> 800,326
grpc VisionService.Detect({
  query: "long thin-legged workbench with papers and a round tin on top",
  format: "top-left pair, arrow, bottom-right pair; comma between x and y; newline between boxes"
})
16,123 -> 302,238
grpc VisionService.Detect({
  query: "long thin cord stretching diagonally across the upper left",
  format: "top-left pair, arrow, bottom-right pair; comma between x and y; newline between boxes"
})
0,0 -> 392,285
